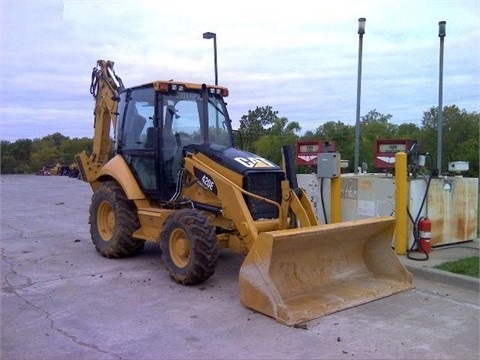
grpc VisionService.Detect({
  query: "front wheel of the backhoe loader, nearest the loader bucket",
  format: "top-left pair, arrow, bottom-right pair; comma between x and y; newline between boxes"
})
160,209 -> 219,285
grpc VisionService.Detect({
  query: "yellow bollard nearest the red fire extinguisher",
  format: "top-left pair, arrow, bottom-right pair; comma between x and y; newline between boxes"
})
394,152 -> 408,255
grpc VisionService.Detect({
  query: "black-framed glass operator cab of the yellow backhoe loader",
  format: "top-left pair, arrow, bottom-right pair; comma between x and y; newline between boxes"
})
115,81 -> 232,202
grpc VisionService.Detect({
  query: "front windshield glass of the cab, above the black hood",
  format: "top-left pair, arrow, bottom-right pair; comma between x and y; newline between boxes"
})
162,91 -> 232,147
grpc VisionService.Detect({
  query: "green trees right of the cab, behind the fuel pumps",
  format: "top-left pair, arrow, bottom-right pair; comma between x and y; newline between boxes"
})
239,105 -> 480,177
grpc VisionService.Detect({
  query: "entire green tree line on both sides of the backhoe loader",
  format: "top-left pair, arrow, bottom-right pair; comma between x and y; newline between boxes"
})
1,105 -> 480,177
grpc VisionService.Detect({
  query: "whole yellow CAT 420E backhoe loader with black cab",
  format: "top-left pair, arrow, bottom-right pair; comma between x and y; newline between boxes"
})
76,60 -> 412,325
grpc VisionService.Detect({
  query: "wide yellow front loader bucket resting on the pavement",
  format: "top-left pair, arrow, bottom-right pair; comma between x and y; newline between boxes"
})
239,217 -> 413,325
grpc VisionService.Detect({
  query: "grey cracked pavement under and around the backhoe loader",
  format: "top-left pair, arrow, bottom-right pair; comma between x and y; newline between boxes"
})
0,175 -> 480,360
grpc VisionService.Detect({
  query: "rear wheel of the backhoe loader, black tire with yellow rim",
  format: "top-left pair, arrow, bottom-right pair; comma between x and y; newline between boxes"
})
90,181 -> 145,258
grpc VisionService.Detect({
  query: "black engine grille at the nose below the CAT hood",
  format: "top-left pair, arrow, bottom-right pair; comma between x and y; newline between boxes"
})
243,172 -> 283,220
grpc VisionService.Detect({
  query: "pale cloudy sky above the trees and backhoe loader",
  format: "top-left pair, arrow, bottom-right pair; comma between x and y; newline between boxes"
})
0,0 -> 480,141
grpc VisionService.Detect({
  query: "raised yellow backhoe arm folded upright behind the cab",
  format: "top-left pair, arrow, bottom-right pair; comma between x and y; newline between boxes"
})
75,60 -> 124,182
